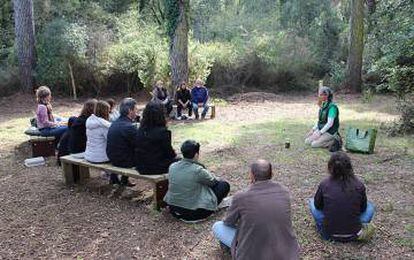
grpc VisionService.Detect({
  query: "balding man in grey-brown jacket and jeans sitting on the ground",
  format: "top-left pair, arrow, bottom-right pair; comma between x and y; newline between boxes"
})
213,160 -> 299,259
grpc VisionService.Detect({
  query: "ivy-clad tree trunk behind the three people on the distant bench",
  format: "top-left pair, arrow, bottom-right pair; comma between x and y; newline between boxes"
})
169,0 -> 190,97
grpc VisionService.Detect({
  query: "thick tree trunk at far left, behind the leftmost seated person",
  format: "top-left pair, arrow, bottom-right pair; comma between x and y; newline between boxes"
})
13,0 -> 35,92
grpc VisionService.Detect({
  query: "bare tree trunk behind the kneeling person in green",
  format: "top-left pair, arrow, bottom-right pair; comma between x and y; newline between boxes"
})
345,0 -> 364,92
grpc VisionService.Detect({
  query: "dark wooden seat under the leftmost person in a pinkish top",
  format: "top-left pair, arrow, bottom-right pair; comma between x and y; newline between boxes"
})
24,127 -> 56,157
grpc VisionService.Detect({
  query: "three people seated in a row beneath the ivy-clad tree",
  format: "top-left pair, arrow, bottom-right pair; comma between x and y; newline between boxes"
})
151,79 -> 209,119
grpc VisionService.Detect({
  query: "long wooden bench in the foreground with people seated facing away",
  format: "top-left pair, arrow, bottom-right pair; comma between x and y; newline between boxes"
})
60,154 -> 168,210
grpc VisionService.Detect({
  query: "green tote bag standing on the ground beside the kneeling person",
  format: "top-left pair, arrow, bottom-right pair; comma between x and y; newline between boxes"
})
345,127 -> 377,153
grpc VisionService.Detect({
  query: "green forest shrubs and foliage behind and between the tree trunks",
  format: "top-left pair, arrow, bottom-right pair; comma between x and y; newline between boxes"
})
0,0 -> 414,104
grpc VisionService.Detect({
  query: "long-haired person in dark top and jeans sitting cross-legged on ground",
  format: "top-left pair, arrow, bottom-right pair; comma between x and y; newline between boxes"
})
309,152 -> 375,242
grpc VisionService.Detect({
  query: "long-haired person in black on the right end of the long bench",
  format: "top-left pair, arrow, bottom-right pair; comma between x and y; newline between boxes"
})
135,102 -> 178,174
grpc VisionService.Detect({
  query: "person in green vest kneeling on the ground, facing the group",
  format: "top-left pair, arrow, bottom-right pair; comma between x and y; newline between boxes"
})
305,87 -> 339,148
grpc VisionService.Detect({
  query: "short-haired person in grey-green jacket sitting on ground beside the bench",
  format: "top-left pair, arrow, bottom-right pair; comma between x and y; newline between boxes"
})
164,140 -> 230,222
